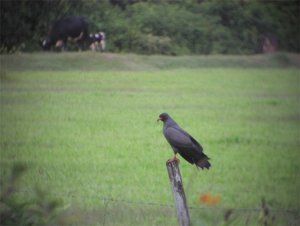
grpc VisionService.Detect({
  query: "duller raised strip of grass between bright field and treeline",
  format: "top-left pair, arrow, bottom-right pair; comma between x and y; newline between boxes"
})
0,52 -> 300,71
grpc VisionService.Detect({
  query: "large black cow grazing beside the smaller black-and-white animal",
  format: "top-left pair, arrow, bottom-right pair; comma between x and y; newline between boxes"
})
41,17 -> 89,50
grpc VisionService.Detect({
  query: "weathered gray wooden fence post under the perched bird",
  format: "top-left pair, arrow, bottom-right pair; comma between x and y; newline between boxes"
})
166,161 -> 190,226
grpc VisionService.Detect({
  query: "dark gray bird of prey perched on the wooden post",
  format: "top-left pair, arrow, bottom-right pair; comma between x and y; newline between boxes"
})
157,113 -> 210,169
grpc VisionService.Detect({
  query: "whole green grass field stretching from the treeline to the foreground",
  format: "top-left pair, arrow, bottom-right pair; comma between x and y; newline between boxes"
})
0,53 -> 300,225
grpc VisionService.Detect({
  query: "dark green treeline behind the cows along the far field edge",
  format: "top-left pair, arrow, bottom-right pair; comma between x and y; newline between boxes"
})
0,0 -> 300,55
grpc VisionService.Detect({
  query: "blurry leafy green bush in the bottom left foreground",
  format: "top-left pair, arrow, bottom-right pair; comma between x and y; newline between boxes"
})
0,164 -> 66,226
